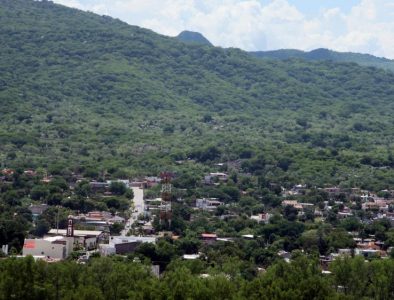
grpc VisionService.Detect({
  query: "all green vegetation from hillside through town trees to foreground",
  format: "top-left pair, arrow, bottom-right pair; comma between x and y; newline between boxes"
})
0,0 -> 394,299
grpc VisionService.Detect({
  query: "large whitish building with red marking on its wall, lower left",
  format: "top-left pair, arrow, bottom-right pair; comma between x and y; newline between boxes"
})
23,236 -> 73,259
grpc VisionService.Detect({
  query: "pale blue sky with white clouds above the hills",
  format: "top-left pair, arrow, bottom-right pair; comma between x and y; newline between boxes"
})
54,0 -> 394,59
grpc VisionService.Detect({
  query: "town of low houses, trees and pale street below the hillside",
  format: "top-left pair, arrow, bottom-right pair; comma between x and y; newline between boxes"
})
0,165 -> 394,276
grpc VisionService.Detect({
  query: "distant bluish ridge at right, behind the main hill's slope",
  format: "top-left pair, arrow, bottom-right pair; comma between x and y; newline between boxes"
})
249,48 -> 394,71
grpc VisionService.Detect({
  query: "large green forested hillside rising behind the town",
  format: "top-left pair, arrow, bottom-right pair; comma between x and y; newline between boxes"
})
0,0 -> 394,188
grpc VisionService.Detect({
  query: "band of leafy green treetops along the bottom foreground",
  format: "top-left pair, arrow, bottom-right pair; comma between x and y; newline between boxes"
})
0,255 -> 394,300
